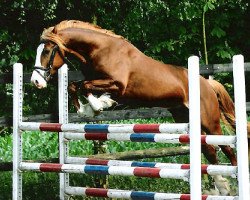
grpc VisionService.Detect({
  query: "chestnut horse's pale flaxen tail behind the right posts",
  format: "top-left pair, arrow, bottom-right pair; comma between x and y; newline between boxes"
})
208,79 -> 250,138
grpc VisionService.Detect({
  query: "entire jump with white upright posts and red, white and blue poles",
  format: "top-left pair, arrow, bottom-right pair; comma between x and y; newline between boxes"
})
13,56 -> 249,200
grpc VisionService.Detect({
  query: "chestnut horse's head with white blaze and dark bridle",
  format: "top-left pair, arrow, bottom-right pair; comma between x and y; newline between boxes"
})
31,41 -> 64,89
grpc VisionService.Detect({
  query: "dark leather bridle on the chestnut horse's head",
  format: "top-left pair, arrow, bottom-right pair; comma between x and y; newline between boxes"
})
34,44 -> 76,82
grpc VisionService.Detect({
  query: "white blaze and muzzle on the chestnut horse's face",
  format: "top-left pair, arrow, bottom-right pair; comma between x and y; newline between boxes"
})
31,43 -> 47,89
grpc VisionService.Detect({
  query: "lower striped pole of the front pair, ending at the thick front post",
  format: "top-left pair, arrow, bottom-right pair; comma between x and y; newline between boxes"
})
20,163 -> 189,181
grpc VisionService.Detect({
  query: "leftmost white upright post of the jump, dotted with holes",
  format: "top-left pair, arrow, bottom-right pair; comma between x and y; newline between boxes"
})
12,63 -> 23,200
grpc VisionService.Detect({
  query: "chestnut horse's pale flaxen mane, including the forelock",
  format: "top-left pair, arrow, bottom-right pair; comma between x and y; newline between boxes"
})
41,20 -> 124,57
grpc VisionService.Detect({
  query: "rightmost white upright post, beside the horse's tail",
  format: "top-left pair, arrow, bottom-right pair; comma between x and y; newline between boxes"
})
233,55 -> 250,200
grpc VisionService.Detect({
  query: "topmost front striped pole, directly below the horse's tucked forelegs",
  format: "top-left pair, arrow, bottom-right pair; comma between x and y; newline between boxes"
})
19,122 -> 189,133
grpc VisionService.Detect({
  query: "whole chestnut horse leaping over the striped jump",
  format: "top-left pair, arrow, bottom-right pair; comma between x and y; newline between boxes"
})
31,20 -> 250,195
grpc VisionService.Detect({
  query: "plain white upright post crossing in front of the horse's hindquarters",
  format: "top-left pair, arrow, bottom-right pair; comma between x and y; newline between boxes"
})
188,56 -> 201,200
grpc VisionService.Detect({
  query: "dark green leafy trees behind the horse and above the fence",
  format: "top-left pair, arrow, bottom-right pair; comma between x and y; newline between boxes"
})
0,0 -> 250,115
